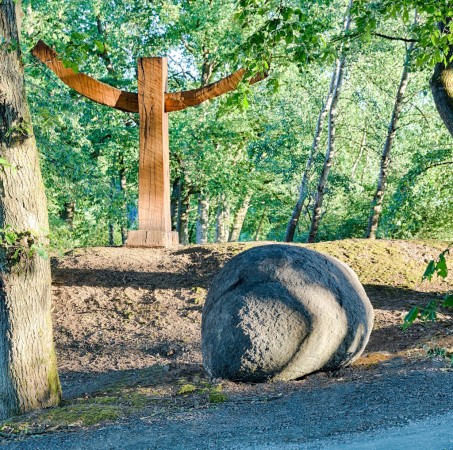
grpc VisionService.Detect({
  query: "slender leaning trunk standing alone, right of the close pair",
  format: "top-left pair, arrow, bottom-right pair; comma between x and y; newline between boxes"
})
365,44 -> 415,239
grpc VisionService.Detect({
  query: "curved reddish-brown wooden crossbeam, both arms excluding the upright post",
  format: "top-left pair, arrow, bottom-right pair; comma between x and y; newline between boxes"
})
32,40 -> 266,113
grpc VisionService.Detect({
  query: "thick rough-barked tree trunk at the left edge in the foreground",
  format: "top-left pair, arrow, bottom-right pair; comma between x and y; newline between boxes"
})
0,0 -> 61,420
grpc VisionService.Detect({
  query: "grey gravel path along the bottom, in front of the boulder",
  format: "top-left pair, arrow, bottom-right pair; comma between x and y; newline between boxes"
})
4,366 -> 453,450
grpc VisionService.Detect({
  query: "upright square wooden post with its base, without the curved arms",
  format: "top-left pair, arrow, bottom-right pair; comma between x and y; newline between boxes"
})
127,58 -> 178,247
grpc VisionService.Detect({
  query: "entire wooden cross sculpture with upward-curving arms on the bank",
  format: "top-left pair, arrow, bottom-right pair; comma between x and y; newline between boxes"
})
32,41 -> 264,247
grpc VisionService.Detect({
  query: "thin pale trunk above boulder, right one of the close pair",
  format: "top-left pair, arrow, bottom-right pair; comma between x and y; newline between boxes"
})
308,0 -> 352,242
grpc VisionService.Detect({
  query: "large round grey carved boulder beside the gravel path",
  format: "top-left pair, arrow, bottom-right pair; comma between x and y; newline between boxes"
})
202,244 -> 374,382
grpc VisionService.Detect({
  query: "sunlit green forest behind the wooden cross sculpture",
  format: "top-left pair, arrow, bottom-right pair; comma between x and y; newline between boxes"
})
22,0 -> 453,250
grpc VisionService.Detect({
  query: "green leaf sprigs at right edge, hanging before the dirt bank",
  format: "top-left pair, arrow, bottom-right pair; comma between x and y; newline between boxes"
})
402,244 -> 453,330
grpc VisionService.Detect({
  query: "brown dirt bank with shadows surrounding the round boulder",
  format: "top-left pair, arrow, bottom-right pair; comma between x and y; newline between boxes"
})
0,240 -> 453,442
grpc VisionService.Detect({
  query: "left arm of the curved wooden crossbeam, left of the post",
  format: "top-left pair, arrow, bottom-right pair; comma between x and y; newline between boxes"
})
31,40 -> 138,113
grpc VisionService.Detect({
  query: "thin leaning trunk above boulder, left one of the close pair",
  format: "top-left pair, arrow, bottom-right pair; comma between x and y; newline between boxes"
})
285,63 -> 337,242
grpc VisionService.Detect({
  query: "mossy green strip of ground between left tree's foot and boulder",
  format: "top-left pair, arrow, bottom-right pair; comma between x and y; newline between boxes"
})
0,371 -> 228,442
